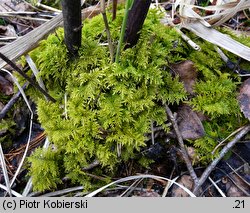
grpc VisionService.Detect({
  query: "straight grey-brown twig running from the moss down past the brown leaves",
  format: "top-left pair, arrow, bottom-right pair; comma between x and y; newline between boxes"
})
165,104 -> 199,187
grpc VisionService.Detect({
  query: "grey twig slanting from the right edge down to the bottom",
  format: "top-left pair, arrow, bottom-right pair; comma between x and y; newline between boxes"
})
193,125 -> 250,195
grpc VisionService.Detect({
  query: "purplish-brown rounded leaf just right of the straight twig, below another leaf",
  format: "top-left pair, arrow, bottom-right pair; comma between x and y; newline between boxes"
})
177,105 -> 205,140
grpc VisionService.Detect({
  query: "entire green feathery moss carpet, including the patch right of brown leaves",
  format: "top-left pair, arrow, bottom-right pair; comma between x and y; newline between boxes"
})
19,10 -> 248,191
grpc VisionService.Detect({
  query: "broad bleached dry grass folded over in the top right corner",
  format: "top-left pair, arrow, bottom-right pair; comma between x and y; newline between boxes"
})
175,0 -> 250,61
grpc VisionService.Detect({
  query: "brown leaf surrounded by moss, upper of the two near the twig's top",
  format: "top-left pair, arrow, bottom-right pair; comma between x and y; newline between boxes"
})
170,60 -> 197,94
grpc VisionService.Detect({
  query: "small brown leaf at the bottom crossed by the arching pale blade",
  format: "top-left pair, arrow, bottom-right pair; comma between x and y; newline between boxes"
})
171,175 -> 194,197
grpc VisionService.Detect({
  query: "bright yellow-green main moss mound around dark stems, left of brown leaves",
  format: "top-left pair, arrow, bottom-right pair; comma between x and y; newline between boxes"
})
26,11 -> 186,190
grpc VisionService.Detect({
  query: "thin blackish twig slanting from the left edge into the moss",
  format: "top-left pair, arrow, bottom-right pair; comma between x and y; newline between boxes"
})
0,53 -> 56,102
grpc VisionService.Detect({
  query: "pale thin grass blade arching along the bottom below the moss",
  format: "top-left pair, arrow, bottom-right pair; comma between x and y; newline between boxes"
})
85,175 -> 196,197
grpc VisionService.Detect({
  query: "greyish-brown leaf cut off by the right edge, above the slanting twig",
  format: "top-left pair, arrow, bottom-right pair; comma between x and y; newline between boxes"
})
238,78 -> 250,120
